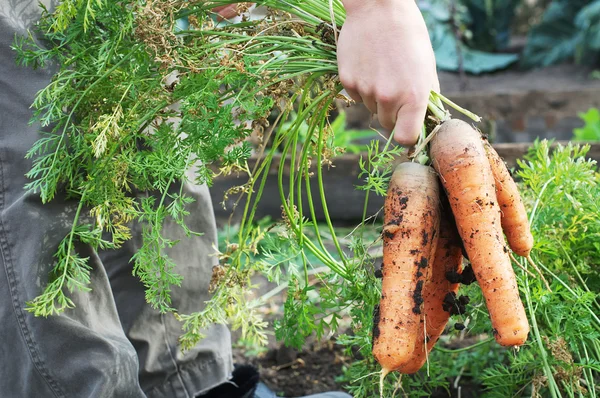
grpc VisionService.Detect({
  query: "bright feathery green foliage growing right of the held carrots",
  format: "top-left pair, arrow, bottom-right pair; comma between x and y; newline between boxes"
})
482,141 -> 600,397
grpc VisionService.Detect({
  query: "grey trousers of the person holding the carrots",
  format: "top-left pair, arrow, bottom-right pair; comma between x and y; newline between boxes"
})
0,0 -> 232,398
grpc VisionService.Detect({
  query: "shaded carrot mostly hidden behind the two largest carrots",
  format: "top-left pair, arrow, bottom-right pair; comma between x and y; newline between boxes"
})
398,206 -> 463,374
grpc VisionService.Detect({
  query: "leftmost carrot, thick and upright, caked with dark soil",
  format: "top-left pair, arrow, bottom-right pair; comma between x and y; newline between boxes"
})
373,163 -> 440,380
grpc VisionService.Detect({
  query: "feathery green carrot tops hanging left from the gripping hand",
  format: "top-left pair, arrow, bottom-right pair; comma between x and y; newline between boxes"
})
14,0 -> 474,349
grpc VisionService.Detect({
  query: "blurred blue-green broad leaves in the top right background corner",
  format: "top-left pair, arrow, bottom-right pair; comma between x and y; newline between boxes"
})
420,0 -> 600,70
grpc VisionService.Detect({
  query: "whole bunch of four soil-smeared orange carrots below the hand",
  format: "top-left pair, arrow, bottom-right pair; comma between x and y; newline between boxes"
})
373,119 -> 544,381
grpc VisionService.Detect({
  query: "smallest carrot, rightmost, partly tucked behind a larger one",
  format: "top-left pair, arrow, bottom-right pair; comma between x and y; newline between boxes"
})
484,140 -> 533,257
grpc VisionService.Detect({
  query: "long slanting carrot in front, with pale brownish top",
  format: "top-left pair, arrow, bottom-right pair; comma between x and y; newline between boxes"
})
430,119 -> 529,346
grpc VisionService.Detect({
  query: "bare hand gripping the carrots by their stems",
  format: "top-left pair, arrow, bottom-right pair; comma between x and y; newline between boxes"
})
337,0 -> 439,145
